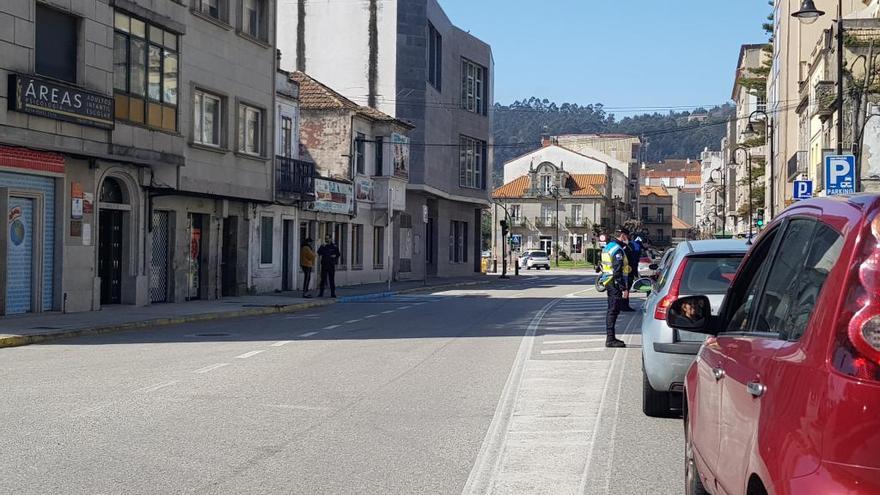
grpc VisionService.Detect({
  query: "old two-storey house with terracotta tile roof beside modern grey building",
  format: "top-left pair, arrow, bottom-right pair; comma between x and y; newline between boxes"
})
291,72 -> 413,285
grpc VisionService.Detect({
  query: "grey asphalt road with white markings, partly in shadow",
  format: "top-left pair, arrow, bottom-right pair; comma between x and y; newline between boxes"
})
0,271 -> 683,495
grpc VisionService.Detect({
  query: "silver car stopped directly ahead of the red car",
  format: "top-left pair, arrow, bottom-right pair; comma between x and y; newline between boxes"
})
633,239 -> 749,417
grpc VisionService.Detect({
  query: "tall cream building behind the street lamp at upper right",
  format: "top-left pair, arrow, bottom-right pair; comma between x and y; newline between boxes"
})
765,0 -> 869,219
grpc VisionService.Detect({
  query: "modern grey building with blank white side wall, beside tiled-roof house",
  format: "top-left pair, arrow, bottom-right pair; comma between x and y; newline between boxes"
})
279,0 -> 494,279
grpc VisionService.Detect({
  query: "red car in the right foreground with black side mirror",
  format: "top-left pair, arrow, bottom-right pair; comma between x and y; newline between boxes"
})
667,194 -> 880,495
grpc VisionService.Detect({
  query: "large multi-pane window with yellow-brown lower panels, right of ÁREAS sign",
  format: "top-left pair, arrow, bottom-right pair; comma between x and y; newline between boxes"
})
113,11 -> 179,131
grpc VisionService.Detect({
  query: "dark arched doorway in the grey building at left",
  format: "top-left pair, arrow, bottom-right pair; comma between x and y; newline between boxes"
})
98,177 -> 131,305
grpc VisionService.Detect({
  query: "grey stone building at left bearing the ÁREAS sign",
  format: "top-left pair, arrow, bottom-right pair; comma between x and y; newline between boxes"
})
0,0 -> 275,314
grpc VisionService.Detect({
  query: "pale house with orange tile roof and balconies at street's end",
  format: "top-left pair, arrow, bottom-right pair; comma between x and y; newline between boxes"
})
492,161 -> 613,259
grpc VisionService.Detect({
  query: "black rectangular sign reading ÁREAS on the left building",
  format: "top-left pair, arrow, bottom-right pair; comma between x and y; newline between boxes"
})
9,74 -> 113,129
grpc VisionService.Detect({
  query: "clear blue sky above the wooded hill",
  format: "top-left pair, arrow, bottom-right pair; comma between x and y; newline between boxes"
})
439,0 -> 771,116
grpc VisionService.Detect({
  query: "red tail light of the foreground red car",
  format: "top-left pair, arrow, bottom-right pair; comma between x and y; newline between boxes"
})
834,215 -> 880,381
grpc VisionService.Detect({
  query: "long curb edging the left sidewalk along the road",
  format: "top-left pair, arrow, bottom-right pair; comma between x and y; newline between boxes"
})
0,280 -> 491,348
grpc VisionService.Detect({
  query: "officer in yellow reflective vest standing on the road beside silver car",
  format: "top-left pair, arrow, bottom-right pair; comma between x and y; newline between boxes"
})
602,227 -> 632,347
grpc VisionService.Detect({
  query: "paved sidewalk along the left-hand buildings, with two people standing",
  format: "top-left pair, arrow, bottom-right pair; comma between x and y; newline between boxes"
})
0,275 -> 495,347
